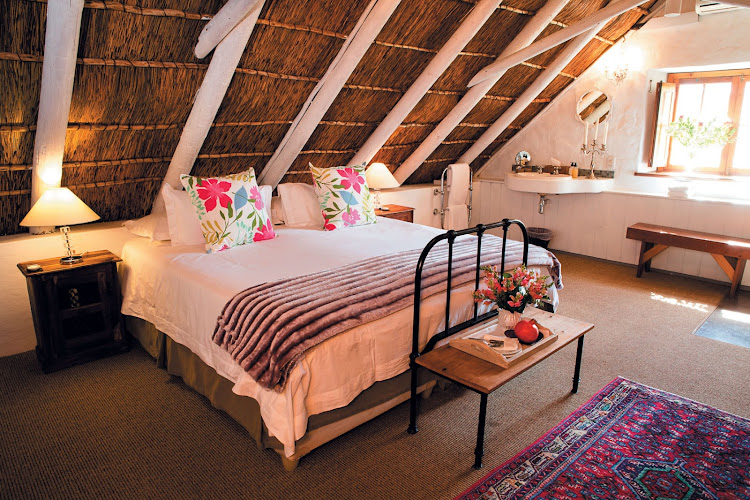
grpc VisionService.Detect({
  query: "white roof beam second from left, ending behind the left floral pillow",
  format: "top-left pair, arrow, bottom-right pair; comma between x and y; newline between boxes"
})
152,0 -> 264,212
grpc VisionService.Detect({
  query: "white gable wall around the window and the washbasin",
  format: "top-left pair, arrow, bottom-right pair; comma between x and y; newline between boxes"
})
479,9 -> 750,286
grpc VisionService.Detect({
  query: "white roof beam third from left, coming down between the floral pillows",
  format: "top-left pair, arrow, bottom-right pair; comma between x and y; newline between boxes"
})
260,0 -> 401,187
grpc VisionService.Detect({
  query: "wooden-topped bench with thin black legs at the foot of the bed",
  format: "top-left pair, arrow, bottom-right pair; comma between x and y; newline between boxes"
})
409,307 -> 594,469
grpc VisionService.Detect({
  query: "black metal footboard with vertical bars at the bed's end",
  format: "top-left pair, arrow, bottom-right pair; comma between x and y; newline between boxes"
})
408,219 -> 529,434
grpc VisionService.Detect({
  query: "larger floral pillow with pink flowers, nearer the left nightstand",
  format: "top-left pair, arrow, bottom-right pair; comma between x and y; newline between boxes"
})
180,169 -> 276,253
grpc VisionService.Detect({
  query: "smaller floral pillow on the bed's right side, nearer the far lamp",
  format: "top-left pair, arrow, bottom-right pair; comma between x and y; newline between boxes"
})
310,163 -> 375,231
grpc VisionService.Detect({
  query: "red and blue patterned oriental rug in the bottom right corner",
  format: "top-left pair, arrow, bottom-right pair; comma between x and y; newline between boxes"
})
458,378 -> 750,500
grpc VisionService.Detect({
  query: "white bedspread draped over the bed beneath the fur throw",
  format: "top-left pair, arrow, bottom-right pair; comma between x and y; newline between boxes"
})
120,218 -> 557,456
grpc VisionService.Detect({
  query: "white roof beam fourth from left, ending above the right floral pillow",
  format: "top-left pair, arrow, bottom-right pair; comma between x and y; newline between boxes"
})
349,0 -> 502,165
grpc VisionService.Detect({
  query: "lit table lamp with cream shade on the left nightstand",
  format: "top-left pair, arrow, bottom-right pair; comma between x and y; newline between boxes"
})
21,188 -> 99,264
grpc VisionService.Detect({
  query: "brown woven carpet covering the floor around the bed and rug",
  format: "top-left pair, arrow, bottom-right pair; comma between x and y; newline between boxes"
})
0,255 -> 750,499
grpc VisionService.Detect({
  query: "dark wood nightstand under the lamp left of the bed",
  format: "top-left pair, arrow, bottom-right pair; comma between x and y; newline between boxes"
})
18,250 -> 129,373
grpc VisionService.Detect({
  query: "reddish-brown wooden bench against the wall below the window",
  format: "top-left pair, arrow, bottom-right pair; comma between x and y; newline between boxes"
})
627,222 -> 750,297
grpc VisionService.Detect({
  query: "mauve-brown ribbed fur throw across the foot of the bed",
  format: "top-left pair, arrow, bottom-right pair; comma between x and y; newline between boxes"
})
213,235 -> 562,390
